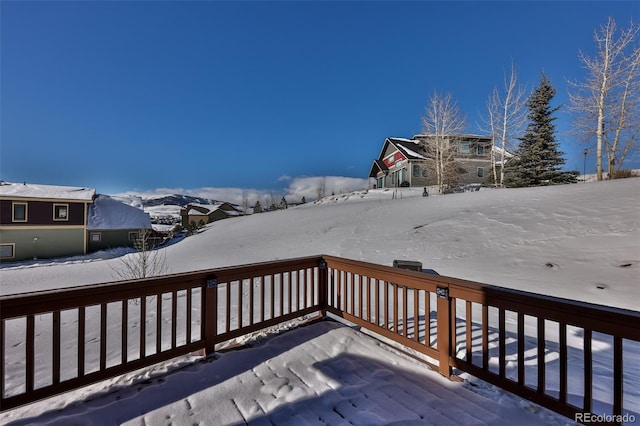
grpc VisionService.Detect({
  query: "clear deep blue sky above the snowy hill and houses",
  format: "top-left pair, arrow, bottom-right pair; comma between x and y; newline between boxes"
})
0,0 -> 640,193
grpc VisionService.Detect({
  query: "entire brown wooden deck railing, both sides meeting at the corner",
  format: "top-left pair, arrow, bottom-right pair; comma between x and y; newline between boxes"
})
0,256 -> 640,419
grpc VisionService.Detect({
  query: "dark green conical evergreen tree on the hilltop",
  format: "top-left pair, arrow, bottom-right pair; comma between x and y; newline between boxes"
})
505,74 -> 577,187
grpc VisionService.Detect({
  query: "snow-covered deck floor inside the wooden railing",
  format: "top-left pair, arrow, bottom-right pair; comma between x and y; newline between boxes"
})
0,321 -> 573,425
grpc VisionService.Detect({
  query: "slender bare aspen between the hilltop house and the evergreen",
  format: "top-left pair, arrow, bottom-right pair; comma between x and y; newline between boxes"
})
486,64 -> 528,187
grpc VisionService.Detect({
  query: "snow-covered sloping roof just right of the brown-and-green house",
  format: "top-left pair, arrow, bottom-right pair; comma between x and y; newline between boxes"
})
87,195 -> 151,230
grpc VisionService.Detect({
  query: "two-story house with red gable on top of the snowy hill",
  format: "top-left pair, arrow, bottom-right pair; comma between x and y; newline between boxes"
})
369,135 -> 504,188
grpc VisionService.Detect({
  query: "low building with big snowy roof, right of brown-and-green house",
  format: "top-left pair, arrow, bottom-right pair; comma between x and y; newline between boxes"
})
87,194 -> 153,252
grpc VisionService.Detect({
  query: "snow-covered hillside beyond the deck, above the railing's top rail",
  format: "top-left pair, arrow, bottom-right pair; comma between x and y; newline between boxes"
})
1,179 -> 640,310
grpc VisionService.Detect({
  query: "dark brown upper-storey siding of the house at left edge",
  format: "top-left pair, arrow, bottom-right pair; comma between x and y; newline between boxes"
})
0,200 -> 85,226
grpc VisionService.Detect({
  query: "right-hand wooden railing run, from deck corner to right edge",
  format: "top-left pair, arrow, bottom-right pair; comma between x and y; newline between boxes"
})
324,256 -> 640,424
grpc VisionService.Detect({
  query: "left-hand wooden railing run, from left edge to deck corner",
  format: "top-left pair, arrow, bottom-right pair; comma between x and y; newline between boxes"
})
0,257 -> 321,411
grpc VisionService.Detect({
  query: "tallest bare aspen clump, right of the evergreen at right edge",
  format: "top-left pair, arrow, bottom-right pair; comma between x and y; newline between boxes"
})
569,17 -> 640,180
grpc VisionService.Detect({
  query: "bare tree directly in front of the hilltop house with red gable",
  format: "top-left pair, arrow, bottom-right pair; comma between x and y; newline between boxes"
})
422,92 -> 466,194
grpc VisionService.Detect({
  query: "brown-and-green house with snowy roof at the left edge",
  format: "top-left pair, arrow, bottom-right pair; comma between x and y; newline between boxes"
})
0,182 -> 96,261
